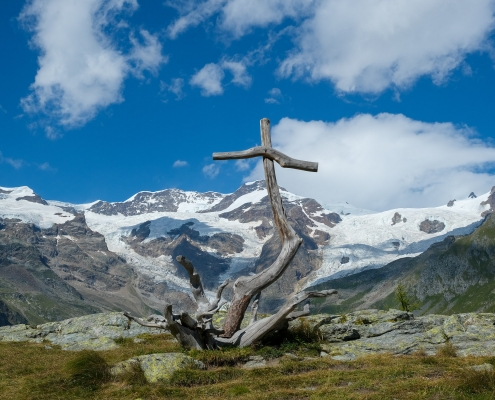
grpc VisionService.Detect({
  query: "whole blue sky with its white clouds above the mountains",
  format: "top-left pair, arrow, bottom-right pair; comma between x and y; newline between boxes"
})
0,0 -> 495,210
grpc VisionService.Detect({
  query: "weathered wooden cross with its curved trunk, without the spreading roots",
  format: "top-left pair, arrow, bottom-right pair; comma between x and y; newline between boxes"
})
213,118 -> 318,337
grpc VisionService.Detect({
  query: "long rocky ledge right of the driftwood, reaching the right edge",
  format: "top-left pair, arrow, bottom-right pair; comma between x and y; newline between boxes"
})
292,309 -> 495,361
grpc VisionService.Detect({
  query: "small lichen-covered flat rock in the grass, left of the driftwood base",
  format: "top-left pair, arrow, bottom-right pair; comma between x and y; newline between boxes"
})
110,353 -> 204,383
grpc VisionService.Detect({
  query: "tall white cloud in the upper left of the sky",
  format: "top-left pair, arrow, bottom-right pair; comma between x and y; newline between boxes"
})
20,0 -> 166,128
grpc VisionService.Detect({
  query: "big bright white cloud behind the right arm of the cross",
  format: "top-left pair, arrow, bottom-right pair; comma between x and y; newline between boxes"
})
246,114 -> 495,210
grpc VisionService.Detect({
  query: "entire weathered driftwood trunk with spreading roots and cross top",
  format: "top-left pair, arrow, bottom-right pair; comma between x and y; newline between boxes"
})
124,118 -> 337,349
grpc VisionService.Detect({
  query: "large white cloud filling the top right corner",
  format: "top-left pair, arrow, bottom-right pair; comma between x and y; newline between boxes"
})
279,0 -> 495,93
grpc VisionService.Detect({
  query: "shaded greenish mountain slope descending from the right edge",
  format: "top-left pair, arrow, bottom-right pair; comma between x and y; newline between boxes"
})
317,194 -> 495,314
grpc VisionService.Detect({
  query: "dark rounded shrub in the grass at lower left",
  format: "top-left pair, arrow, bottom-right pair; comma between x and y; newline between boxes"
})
66,350 -> 110,388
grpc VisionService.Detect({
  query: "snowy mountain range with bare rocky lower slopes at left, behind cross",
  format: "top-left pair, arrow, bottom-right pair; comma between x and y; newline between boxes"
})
0,181 -> 495,325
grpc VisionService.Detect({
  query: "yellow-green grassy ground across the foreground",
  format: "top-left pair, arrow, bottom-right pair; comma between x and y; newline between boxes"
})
0,335 -> 495,400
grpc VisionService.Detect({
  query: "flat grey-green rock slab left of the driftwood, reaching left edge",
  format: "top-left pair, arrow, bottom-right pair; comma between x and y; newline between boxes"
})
0,312 -> 164,350
